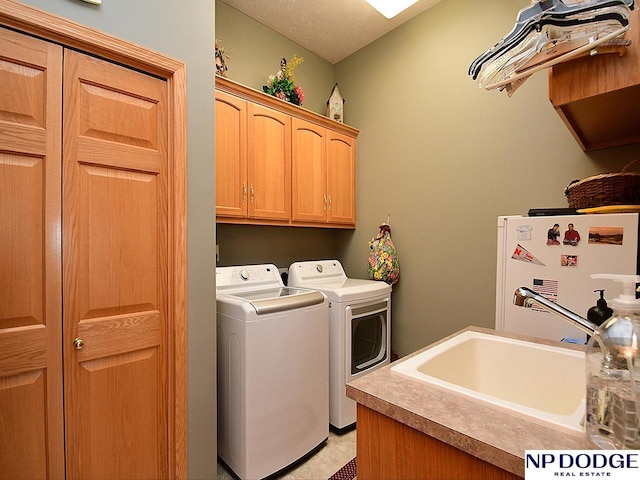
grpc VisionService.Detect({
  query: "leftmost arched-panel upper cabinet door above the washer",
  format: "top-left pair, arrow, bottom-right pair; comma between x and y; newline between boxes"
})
216,90 -> 248,218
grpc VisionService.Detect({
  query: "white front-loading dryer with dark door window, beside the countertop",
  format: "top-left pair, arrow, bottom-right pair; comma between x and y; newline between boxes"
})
288,260 -> 391,433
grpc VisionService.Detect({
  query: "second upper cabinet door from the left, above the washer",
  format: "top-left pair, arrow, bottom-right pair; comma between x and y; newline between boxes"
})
247,103 -> 291,221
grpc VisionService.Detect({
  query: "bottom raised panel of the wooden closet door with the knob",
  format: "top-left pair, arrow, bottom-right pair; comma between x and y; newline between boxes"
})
76,343 -> 161,479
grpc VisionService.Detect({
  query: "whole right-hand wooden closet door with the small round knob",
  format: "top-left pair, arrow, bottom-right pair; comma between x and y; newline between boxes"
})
62,50 -> 171,479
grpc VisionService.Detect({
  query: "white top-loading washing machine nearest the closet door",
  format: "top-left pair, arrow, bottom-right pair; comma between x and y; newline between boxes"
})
216,265 -> 329,480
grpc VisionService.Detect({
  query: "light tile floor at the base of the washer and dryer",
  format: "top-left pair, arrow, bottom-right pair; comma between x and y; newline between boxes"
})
218,430 -> 356,480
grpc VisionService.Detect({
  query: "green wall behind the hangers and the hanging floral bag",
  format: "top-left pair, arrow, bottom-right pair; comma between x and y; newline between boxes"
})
336,0 -> 640,355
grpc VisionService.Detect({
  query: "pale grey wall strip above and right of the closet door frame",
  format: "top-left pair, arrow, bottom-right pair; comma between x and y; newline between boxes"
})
15,0 -> 217,480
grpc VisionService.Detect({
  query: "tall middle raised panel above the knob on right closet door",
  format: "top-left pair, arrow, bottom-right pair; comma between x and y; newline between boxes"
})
76,164 -> 161,322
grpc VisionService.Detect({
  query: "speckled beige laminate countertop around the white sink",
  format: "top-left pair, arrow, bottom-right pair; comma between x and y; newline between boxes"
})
347,327 -> 590,477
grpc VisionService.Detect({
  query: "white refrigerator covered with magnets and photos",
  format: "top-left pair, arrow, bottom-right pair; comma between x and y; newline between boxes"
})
496,213 -> 640,343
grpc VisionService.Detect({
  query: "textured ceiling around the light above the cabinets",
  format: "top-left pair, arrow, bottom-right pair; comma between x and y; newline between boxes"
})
222,0 -> 440,63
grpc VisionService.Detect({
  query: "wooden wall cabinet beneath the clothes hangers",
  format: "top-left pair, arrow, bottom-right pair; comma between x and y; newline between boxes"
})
549,8 -> 640,151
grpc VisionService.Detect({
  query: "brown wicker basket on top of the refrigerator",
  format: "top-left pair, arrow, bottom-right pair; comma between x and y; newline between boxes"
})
564,161 -> 640,208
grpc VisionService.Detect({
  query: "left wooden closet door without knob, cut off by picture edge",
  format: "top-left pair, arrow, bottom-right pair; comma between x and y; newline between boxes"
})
0,28 -> 64,479
